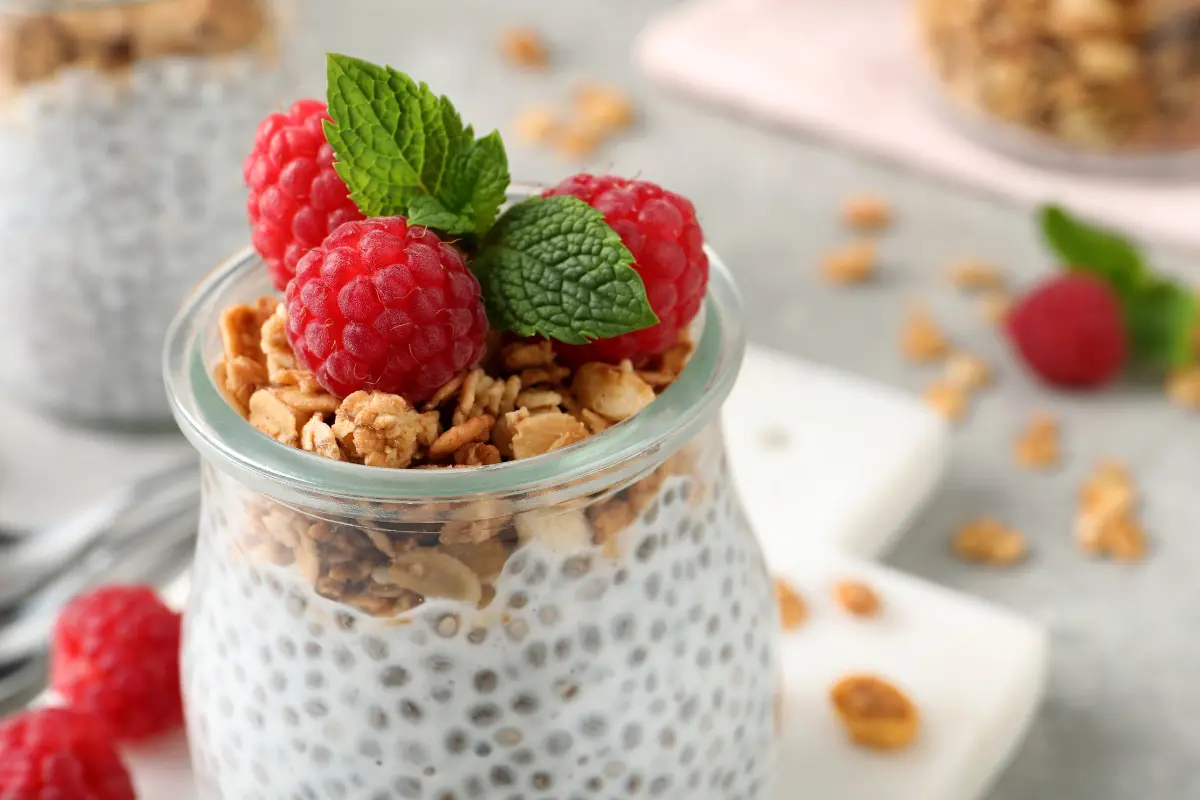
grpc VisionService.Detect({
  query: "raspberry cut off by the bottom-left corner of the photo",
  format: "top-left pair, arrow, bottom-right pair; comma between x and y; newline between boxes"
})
0,709 -> 134,800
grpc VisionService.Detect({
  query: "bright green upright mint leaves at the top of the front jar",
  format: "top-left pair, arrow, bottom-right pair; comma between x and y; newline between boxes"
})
325,54 -> 509,235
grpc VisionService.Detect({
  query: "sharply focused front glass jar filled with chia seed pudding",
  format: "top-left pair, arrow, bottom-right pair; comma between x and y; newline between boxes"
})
166,235 -> 780,800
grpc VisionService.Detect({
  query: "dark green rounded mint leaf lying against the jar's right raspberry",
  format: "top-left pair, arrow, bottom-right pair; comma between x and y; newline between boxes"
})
474,197 -> 659,344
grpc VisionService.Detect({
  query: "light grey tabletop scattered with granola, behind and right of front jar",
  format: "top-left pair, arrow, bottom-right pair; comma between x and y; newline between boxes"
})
290,0 -> 1200,800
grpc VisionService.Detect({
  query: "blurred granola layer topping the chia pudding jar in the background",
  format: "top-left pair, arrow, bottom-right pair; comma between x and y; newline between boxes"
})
0,0 -> 272,86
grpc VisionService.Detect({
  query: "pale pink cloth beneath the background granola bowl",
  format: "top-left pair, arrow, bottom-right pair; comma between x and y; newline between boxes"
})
636,0 -> 1200,248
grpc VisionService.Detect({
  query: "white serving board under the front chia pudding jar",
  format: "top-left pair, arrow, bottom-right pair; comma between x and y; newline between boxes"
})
0,348 -> 1044,800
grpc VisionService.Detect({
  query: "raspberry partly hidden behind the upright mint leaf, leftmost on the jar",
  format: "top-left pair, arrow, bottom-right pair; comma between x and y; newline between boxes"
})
242,100 -> 362,291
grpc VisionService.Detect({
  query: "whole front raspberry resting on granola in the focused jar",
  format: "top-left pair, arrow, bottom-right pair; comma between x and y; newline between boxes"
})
287,217 -> 487,403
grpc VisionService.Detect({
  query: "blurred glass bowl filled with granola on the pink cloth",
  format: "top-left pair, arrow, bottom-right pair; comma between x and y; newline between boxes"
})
917,0 -> 1200,176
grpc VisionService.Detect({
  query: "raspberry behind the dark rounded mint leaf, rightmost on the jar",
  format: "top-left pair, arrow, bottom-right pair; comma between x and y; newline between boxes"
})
546,173 -> 708,363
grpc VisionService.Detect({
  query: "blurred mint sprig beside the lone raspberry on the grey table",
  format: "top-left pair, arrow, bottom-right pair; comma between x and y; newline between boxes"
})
1039,205 -> 1200,371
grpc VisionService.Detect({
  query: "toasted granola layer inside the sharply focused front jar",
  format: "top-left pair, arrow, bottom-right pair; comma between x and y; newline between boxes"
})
206,297 -> 703,616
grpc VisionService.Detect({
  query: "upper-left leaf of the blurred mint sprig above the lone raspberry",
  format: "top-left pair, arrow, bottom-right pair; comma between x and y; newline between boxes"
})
1039,205 -> 1148,295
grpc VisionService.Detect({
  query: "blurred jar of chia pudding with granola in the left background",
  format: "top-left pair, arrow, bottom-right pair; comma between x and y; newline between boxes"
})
0,0 -> 293,427
